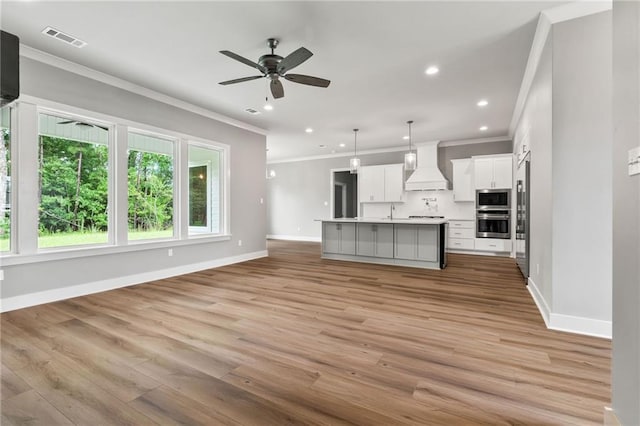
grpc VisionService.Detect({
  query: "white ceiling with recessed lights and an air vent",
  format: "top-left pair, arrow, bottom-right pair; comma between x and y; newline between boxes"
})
1,1 -> 566,161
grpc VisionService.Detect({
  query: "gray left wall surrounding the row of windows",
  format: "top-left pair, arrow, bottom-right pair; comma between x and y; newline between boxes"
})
2,58 -> 266,298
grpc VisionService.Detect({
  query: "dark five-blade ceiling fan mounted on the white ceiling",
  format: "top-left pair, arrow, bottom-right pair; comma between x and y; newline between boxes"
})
220,38 -> 331,99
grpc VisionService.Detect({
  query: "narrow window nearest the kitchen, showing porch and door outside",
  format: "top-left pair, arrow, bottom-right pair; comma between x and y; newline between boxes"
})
189,143 -> 223,235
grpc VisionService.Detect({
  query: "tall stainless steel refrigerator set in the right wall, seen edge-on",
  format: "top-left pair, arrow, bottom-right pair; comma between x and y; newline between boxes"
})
516,156 -> 531,280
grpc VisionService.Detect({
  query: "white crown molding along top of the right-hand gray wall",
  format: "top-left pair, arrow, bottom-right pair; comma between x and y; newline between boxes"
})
509,0 -> 612,138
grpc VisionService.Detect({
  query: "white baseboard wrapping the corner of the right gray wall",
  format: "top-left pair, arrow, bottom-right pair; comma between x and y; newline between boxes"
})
527,278 -> 613,339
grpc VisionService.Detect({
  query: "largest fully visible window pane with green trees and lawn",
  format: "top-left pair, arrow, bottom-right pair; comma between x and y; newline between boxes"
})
38,113 -> 109,248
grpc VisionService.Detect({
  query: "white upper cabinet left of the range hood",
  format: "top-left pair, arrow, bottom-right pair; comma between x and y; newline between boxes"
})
358,164 -> 404,203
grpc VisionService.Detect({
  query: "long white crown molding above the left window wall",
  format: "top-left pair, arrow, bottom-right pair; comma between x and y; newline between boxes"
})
20,43 -> 268,136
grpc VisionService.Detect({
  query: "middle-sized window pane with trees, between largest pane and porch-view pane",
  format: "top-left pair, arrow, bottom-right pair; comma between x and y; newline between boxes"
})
127,132 -> 174,240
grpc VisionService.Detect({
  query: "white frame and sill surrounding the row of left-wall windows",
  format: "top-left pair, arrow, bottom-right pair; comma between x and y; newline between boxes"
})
0,95 -> 231,266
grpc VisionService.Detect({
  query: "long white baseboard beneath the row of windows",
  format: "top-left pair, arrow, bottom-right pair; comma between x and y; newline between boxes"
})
0,250 -> 269,312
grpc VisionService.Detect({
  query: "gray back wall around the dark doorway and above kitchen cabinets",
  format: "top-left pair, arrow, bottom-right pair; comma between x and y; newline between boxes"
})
267,142 -> 512,240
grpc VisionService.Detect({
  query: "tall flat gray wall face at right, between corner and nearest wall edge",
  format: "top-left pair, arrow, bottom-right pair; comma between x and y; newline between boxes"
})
551,12 -> 612,321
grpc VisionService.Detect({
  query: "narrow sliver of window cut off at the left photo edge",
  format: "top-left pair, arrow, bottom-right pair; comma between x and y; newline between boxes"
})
0,107 -> 11,252
